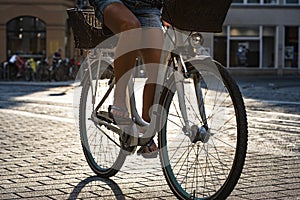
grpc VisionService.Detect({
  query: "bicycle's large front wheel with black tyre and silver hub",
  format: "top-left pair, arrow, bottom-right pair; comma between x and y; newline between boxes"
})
159,60 -> 247,199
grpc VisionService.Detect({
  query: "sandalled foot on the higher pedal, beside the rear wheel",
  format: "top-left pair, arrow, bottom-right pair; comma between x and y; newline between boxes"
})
108,105 -> 132,125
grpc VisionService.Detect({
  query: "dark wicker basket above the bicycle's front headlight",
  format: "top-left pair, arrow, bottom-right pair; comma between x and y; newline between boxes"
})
162,0 -> 231,32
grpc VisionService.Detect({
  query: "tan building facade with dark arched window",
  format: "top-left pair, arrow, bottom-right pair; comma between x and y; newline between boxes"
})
0,0 -> 74,62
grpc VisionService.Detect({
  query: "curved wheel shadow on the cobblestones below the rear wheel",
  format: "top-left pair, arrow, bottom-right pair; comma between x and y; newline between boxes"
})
68,176 -> 125,200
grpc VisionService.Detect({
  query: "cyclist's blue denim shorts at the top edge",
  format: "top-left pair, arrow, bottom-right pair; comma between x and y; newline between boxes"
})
90,0 -> 162,28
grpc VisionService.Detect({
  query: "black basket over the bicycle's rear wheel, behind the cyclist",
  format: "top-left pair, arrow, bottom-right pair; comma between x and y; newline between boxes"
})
67,8 -> 113,49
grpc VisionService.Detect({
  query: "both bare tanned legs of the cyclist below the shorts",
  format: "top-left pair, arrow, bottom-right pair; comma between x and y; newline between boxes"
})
104,3 -> 163,155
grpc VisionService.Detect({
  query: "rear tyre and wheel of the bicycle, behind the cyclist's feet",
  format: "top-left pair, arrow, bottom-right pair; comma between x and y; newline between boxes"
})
79,58 -> 126,178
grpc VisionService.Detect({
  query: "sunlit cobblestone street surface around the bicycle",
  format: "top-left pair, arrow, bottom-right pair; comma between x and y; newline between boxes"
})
0,77 -> 300,200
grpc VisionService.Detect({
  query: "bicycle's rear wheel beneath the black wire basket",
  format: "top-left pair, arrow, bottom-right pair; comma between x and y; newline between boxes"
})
79,60 -> 126,178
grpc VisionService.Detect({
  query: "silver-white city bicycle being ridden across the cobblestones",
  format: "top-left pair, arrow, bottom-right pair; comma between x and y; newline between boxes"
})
68,0 -> 248,199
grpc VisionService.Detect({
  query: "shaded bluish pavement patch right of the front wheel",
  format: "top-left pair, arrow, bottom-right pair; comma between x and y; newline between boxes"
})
234,76 -> 300,114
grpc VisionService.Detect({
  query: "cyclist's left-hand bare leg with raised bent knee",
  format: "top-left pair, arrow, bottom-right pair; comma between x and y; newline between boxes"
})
103,3 -> 141,112
